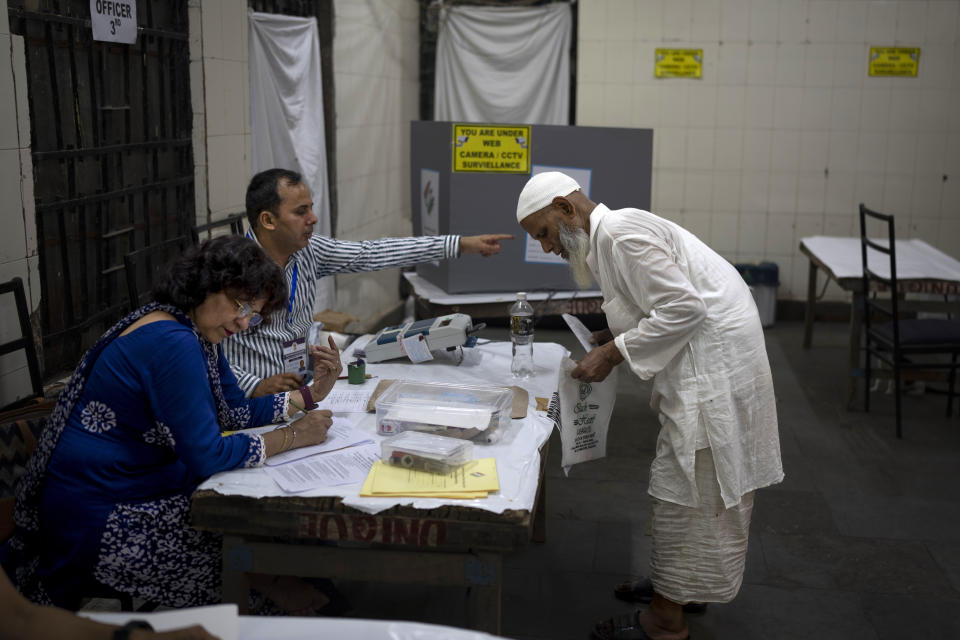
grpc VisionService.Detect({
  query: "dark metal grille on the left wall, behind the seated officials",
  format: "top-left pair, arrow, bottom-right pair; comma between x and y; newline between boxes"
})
9,0 -> 194,373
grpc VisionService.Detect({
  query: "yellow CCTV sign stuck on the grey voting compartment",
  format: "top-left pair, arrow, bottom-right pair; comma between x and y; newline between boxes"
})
453,124 -> 531,173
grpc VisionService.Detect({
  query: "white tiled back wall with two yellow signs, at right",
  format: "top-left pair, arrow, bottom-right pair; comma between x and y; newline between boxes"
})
577,0 -> 960,299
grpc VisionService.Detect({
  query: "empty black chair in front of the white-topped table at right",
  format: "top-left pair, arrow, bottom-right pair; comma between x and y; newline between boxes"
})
860,204 -> 960,438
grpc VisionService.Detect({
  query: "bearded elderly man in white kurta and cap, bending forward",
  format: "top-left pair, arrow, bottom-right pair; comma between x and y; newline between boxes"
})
517,172 -> 783,640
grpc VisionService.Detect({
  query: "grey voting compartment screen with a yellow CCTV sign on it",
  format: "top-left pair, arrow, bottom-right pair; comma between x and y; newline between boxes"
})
410,121 -> 653,293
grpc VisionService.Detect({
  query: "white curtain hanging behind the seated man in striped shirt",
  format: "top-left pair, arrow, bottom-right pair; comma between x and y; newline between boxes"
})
249,12 -> 333,310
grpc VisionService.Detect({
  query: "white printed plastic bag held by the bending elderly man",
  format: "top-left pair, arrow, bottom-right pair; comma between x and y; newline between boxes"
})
557,358 -> 617,475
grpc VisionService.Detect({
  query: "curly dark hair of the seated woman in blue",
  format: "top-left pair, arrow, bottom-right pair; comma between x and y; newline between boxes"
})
153,235 -> 287,322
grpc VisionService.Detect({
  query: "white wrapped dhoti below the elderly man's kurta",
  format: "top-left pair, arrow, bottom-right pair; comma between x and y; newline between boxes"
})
650,449 -> 754,604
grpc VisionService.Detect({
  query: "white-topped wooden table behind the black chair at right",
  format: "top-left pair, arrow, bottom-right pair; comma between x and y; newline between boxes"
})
800,236 -> 960,409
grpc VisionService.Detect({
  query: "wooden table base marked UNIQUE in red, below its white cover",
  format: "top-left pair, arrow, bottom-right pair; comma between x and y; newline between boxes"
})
191,445 -> 547,634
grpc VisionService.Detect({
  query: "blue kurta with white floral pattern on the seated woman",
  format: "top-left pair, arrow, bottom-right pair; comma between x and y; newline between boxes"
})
4,317 -> 286,608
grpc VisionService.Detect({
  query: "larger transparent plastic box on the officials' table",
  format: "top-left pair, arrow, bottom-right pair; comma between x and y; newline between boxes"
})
374,380 -> 513,443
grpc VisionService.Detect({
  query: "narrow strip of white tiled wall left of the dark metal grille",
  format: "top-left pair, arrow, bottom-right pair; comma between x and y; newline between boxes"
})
0,0 -> 40,405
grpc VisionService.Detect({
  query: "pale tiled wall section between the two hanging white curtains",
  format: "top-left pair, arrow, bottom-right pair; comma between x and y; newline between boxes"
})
333,0 -> 420,320
